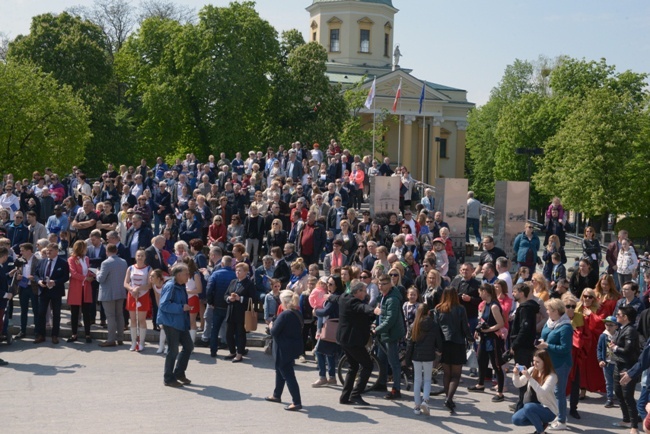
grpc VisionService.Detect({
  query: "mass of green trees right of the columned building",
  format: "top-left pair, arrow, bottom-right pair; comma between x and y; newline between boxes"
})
467,57 -> 650,217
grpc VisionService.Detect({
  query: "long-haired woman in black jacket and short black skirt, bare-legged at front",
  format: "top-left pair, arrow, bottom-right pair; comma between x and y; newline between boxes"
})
434,288 -> 474,414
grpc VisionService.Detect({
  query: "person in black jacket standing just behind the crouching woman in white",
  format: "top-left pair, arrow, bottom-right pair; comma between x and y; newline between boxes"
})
510,283 -> 539,411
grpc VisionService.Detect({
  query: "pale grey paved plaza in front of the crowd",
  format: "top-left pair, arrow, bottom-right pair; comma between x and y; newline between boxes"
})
0,339 -> 623,433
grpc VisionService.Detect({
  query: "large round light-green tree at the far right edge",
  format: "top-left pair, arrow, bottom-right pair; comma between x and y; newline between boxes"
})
535,88 -> 647,216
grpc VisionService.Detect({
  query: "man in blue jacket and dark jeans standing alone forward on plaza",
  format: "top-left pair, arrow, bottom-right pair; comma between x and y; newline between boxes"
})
158,264 -> 194,387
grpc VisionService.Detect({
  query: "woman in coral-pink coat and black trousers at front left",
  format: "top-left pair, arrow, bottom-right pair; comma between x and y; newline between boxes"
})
68,240 -> 95,343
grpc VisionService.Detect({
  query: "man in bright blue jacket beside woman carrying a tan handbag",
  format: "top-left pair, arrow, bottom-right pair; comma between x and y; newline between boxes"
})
206,256 -> 237,357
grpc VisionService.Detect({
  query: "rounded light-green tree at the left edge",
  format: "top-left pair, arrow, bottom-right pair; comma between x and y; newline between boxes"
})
0,61 -> 91,178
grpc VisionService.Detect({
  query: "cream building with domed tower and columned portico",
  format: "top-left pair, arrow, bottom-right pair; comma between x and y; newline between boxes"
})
307,0 -> 474,184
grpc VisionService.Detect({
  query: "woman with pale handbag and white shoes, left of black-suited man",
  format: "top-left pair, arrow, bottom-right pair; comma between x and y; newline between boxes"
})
311,276 -> 345,387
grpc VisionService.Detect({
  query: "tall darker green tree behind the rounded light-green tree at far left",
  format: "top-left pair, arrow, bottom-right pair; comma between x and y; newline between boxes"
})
8,12 -> 135,174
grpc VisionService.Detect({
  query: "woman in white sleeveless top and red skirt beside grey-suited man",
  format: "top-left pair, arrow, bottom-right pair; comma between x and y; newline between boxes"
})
124,249 -> 151,352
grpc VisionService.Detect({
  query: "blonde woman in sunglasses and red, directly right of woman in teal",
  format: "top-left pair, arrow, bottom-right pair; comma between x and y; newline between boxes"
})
562,292 -> 589,419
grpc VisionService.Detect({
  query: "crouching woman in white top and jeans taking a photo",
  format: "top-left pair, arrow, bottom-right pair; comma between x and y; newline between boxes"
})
512,350 -> 558,433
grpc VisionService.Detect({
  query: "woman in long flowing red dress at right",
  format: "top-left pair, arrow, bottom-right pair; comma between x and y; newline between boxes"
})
578,288 -> 606,399
